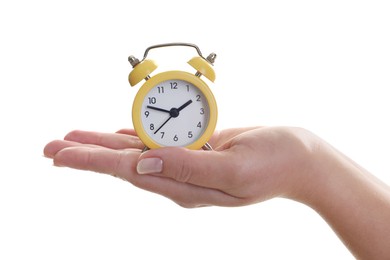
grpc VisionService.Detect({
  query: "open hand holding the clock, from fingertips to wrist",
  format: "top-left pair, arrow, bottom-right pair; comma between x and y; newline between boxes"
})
44,127 -> 316,207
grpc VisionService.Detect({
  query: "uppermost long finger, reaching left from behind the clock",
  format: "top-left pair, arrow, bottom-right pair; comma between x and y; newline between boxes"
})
64,130 -> 144,149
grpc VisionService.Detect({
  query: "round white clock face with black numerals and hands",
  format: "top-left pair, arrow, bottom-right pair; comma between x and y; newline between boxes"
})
140,79 -> 210,146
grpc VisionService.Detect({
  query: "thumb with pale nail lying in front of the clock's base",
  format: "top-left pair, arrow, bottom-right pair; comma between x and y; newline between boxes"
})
137,147 -> 237,189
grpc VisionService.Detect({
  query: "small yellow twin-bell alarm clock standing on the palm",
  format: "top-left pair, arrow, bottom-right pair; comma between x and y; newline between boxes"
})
129,43 -> 217,150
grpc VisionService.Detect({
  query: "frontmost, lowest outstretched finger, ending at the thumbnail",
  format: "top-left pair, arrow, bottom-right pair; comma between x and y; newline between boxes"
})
53,146 -> 141,179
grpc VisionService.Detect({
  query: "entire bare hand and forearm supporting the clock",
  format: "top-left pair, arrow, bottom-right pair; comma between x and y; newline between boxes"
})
44,127 -> 390,259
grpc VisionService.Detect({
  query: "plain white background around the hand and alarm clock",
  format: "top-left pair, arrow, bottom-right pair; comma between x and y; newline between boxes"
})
0,0 -> 390,259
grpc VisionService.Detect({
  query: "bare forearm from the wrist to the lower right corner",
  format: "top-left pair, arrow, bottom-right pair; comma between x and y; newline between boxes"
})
299,145 -> 390,259
